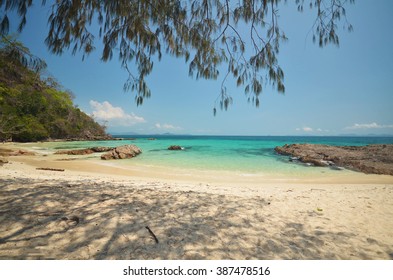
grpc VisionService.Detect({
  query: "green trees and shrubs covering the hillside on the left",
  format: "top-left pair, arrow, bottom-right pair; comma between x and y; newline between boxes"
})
0,38 -> 106,142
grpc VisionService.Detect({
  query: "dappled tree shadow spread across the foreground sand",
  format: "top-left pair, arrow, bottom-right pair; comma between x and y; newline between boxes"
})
0,179 -> 393,259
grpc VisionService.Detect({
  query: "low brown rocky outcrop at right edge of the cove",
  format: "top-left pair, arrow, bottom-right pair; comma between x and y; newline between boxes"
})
275,144 -> 393,175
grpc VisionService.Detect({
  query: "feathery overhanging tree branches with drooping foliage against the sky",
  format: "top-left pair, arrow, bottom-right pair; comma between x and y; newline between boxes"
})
0,0 -> 354,113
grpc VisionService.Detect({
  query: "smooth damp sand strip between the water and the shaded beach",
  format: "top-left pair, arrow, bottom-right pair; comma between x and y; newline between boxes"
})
0,143 -> 393,187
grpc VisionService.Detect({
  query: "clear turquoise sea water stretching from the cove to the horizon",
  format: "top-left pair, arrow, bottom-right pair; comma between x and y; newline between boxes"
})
31,135 -> 393,174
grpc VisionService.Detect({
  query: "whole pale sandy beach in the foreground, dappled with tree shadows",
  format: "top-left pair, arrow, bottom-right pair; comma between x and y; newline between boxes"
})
0,144 -> 393,259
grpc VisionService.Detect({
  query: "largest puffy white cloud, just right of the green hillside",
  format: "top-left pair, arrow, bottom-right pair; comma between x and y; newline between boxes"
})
89,100 -> 146,126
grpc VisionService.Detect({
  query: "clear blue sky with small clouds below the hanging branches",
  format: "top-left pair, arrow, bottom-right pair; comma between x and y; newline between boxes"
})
5,0 -> 393,135
